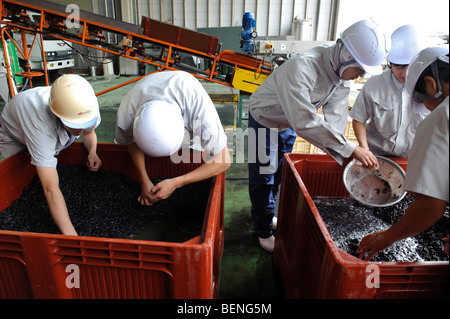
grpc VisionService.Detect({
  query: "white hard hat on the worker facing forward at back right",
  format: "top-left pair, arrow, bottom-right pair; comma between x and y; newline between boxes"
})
387,24 -> 425,65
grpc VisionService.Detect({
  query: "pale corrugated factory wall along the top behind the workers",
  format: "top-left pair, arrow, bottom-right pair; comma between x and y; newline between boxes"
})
47,0 -> 449,41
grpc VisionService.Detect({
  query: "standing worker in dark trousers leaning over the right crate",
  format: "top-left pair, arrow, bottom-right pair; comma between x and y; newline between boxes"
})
248,20 -> 390,251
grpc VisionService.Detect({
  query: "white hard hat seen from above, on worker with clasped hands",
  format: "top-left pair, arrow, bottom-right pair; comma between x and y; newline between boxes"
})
133,99 -> 184,157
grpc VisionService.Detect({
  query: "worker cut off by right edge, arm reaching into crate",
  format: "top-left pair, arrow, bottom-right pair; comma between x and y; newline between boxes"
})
358,47 -> 449,260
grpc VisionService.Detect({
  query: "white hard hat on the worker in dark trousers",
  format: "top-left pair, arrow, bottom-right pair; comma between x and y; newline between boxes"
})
341,20 -> 391,74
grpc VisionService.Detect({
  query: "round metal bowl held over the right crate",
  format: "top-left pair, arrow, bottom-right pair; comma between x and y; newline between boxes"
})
343,156 -> 406,207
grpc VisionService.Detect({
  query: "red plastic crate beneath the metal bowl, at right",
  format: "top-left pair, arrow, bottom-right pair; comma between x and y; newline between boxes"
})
274,154 -> 449,299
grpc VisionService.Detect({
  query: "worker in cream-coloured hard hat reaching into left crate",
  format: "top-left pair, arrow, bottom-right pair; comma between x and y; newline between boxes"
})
0,74 -> 102,235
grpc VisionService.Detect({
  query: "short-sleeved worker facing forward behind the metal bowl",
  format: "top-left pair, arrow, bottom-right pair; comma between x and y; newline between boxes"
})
350,25 -> 428,158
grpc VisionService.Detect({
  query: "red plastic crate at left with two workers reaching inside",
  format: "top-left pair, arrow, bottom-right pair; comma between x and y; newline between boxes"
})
0,143 -> 225,298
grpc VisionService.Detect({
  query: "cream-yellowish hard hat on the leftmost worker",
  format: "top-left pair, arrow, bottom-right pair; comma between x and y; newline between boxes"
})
49,74 -> 100,129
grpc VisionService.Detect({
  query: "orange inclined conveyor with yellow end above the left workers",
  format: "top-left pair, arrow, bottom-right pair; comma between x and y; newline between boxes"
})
0,0 -> 272,97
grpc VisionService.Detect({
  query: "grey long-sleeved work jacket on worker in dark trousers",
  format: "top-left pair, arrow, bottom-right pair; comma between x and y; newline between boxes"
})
249,45 -> 356,164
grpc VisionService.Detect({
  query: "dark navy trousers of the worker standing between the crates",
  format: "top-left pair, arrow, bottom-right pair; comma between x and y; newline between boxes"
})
248,114 -> 297,238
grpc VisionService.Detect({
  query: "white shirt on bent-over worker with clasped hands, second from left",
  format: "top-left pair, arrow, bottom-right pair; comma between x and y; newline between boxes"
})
115,71 -> 227,156
